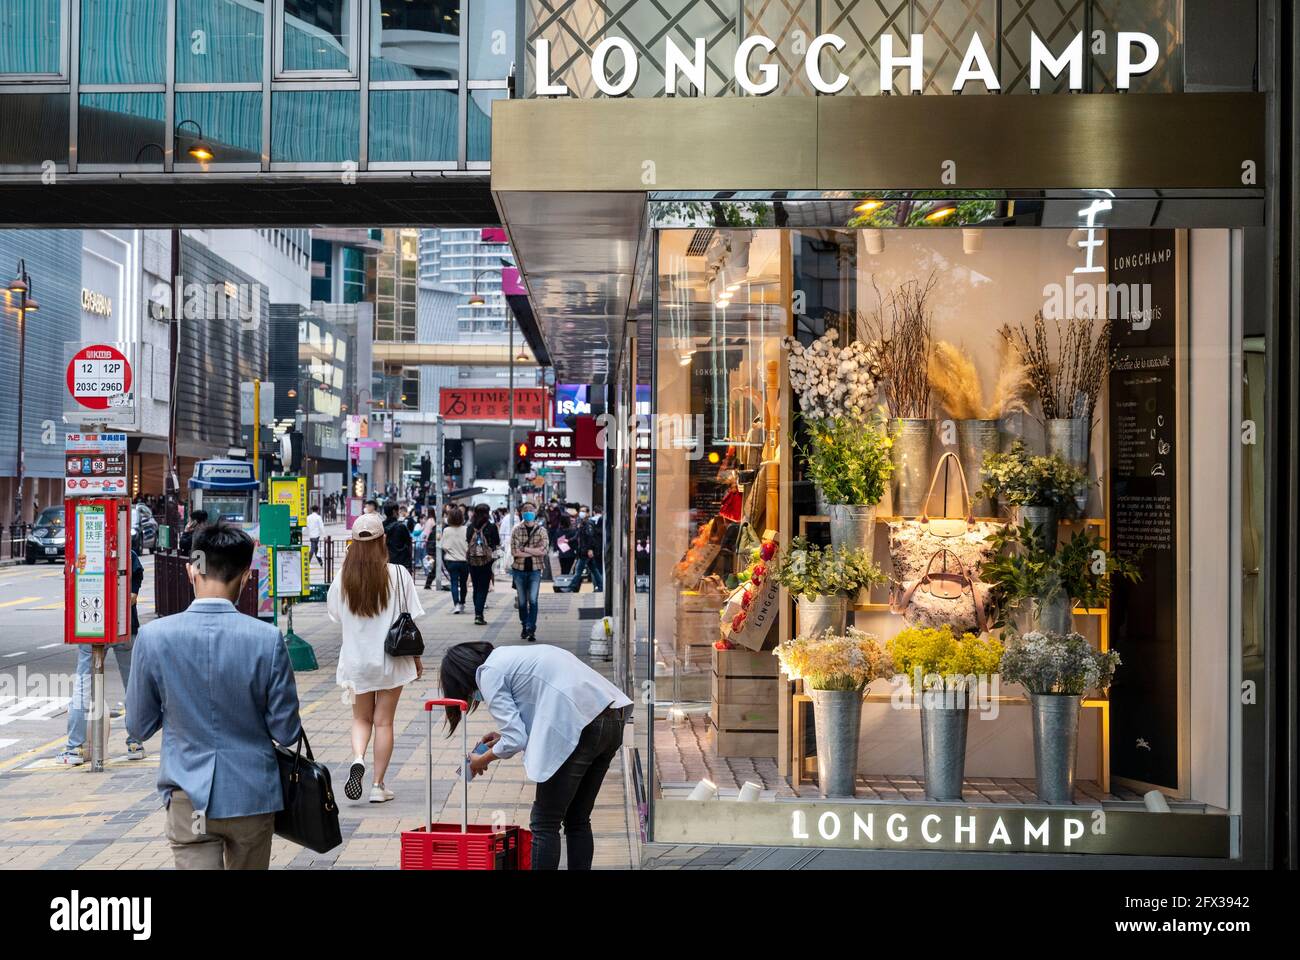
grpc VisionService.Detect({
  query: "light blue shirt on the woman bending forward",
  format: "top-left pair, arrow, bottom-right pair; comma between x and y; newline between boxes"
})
476,644 -> 632,783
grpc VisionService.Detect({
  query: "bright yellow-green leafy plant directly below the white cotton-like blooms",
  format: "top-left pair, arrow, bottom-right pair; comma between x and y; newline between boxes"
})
803,412 -> 893,506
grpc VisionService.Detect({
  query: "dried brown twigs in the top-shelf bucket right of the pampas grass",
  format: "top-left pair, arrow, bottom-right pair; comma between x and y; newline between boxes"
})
1002,311 -> 1112,424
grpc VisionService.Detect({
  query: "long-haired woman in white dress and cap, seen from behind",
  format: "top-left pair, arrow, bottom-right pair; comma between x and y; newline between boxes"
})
326,514 -> 424,804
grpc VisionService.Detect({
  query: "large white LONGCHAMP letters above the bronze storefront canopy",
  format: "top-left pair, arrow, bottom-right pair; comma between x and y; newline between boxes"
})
534,30 -> 1160,96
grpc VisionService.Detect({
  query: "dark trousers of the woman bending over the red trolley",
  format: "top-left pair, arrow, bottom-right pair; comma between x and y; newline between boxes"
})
528,708 -> 629,870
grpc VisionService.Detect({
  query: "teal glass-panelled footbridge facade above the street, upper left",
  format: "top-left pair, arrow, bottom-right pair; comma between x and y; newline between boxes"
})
0,0 -> 519,173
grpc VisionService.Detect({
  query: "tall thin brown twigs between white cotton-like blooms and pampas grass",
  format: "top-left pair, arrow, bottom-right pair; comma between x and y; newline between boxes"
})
867,273 -> 939,420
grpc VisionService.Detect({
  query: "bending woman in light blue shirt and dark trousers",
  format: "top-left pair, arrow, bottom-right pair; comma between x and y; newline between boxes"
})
439,641 -> 632,870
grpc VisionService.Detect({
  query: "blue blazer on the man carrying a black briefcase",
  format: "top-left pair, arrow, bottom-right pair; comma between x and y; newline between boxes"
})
126,600 -> 303,820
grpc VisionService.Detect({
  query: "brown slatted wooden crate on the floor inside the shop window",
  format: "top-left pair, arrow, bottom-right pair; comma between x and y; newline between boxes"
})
709,649 -> 780,757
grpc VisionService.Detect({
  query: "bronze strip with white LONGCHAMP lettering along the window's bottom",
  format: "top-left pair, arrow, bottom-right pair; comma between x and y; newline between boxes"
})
654,799 -> 1231,859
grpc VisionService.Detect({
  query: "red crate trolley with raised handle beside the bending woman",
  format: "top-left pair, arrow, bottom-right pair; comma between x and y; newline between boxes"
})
402,700 -> 533,870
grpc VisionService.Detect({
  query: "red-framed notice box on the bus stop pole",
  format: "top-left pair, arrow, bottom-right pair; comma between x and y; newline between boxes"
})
64,498 -> 131,644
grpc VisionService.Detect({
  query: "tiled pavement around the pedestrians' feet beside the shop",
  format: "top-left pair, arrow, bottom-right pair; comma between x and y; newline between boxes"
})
0,574 -> 637,869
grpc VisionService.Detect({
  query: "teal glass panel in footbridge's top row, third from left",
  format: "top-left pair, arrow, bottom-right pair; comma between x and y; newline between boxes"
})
176,0 -> 265,83
